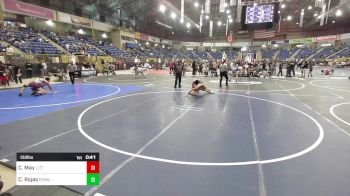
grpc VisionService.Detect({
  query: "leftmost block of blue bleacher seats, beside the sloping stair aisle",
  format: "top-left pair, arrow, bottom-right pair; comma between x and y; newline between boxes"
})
0,28 -> 62,54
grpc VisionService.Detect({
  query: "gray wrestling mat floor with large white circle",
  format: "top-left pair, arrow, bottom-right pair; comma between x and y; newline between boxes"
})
0,68 -> 350,196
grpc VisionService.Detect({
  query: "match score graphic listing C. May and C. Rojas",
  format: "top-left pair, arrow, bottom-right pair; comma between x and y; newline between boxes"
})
16,153 -> 100,186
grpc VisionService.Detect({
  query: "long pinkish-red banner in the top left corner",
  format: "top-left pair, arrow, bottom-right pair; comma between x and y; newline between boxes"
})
1,0 -> 56,20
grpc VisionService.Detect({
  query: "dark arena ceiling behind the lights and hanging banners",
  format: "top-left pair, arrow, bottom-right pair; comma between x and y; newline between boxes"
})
23,0 -> 350,40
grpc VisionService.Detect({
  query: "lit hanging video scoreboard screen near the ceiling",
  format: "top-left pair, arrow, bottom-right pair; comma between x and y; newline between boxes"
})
245,4 -> 275,24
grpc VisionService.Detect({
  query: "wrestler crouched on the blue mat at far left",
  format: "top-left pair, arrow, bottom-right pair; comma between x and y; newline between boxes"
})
19,77 -> 54,96
